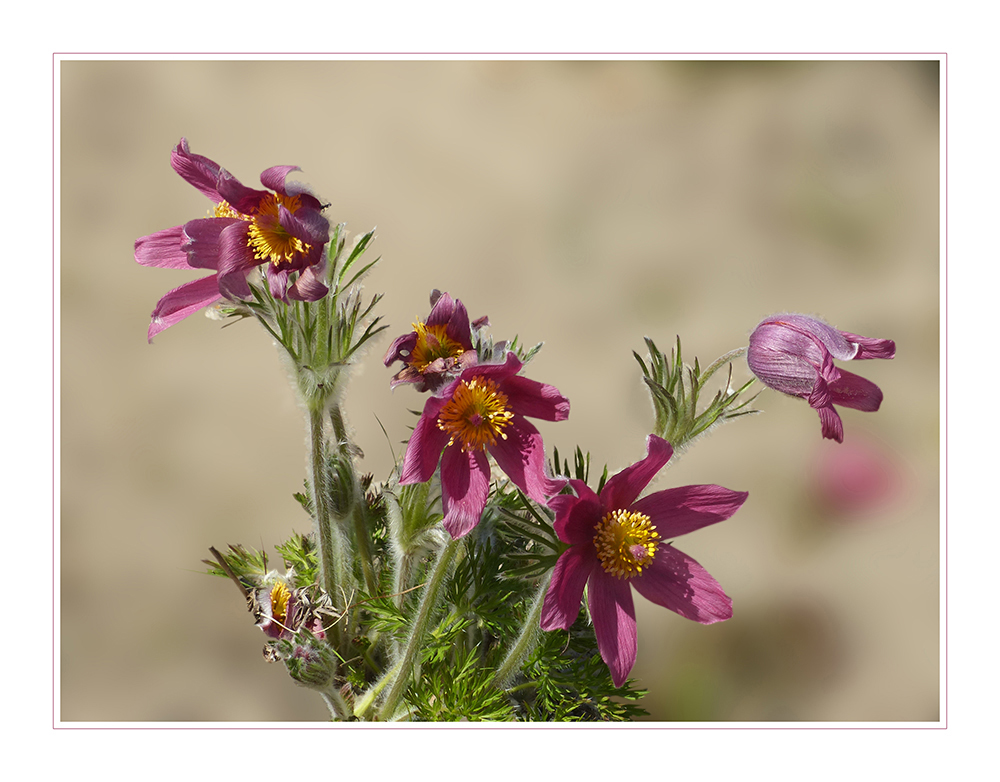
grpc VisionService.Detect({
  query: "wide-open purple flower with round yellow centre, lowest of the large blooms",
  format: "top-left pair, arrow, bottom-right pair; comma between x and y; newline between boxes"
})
541,434 -> 747,687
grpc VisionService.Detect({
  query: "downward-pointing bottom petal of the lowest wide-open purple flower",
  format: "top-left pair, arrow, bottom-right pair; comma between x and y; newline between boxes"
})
587,567 -> 637,687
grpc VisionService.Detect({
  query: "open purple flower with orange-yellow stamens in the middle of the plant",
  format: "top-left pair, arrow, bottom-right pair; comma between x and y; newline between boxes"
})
399,353 -> 569,538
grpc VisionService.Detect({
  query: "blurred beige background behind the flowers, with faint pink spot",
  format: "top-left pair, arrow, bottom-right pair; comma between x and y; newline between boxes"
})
59,61 -> 941,721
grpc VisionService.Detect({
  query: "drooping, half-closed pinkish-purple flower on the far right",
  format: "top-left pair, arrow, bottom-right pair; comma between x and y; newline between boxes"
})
747,314 -> 896,443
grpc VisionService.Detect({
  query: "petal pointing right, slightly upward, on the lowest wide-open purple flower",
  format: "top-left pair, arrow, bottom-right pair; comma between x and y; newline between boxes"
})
630,484 -> 748,539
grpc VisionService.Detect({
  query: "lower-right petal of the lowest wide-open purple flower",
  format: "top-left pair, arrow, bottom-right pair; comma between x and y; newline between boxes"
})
636,545 -> 733,625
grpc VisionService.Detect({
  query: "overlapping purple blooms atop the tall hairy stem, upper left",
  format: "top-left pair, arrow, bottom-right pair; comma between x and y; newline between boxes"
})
135,138 -> 330,341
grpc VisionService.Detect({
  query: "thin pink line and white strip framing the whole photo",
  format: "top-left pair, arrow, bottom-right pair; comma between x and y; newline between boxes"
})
51,52 -> 948,731
